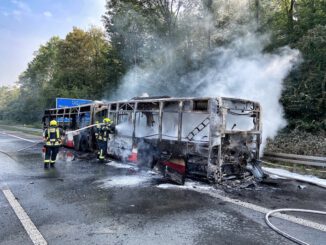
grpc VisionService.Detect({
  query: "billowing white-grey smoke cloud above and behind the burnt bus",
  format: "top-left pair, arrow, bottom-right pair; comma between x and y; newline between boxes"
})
107,0 -> 300,149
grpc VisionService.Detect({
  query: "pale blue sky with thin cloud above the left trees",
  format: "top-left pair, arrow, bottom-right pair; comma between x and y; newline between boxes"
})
0,0 -> 106,86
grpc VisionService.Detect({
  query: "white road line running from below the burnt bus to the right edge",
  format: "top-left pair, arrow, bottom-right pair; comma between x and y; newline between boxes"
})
158,184 -> 326,232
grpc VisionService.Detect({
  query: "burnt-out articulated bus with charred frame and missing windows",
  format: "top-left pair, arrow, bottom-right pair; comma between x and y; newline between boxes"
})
43,97 -> 264,184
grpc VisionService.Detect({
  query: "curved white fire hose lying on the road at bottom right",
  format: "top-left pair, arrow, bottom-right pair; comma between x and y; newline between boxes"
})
265,208 -> 326,245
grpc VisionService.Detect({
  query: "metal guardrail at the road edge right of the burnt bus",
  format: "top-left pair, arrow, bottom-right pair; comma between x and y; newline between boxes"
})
263,152 -> 326,168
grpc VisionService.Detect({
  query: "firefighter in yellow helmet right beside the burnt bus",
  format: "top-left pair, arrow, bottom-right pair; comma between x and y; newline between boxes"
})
97,118 -> 113,162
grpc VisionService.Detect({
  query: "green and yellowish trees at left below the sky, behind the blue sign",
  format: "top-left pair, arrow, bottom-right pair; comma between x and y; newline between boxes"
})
0,28 -> 122,123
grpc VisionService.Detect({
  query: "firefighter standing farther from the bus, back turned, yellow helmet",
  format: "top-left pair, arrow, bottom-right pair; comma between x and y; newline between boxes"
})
43,120 -> 63,168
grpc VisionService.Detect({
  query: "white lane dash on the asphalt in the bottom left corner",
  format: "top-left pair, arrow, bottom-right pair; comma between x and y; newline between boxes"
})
2,189 -> 47,245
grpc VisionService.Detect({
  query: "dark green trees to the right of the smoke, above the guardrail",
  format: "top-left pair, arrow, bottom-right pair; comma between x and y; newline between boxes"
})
261,0 -> 326,132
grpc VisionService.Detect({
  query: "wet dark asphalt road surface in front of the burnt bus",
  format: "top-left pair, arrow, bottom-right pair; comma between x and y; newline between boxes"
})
0,132 -> 326,245
